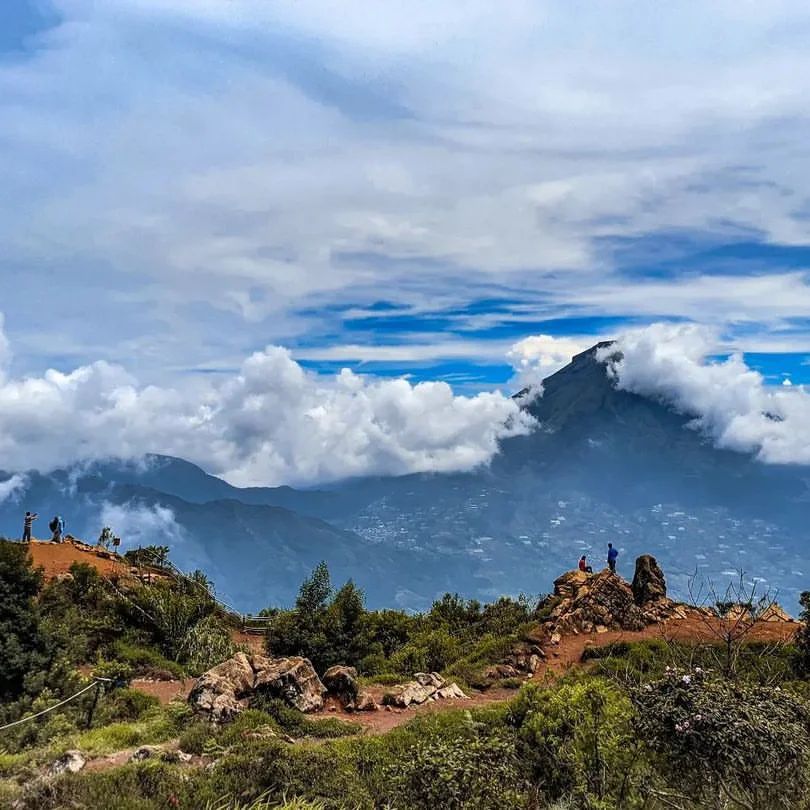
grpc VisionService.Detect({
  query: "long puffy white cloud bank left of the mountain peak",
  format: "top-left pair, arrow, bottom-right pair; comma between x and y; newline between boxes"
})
0,316 -> 532,485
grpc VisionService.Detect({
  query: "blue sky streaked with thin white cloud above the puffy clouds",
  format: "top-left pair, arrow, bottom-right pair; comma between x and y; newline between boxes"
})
0,0 -> 810,392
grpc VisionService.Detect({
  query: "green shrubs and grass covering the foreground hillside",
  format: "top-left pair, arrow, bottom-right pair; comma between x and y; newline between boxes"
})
0,543 -> 810,810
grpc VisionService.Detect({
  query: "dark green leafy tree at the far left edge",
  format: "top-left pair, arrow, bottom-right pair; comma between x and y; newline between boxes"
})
0,540 -> 48,702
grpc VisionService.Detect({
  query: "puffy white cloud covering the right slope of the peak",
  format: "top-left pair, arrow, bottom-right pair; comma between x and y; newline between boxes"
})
600,324 -> 810,464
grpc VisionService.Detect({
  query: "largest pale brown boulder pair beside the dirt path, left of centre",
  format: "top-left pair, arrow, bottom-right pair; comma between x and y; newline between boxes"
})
188,652 -> 326,722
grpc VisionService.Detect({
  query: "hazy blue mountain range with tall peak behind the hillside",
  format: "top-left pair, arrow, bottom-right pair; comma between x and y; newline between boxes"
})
0,344 -> 810,609
